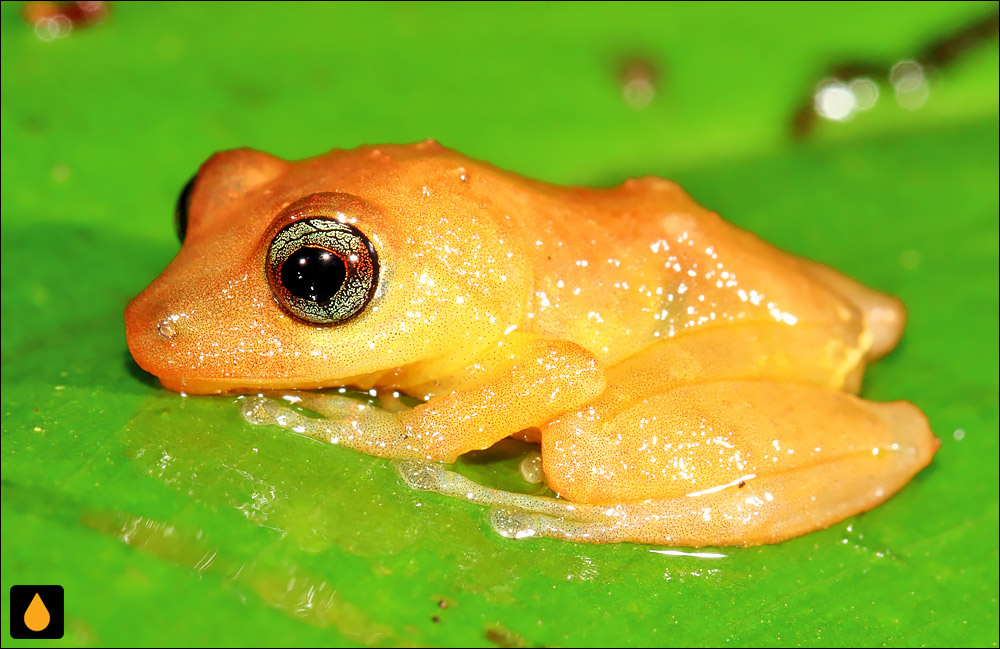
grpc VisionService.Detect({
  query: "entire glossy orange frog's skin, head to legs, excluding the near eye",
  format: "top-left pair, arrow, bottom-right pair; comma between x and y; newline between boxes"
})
125,141 -> 939,546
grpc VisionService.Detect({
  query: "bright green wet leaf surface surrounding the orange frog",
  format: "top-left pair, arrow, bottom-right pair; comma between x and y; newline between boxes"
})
0,2 -> 998,646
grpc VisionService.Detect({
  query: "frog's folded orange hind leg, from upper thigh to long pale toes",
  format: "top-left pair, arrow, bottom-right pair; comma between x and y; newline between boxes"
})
397,323 -> 937,546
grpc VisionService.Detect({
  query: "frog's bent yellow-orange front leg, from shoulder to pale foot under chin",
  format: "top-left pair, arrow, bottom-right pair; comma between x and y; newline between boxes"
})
241,333 -> 605,461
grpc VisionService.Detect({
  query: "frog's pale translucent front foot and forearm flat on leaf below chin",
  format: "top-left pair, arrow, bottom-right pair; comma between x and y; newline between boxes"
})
239,392 -> 425,458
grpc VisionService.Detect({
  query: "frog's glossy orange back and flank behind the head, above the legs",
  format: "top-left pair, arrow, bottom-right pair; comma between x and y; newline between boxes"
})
488,172 -> 868,364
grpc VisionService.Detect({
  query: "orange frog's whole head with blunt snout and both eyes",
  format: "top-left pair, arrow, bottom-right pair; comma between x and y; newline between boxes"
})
125,144 -> 529,393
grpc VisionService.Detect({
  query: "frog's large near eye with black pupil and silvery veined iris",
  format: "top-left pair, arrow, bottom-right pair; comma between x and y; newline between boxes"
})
266,217 -> 379,325
